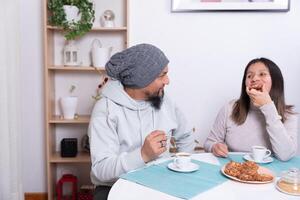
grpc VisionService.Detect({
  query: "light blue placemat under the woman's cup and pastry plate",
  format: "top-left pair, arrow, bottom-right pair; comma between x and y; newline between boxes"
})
218,154 -> 300,176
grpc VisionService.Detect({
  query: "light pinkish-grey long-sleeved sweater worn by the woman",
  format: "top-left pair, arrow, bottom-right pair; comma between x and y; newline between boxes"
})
204,101 -> 298,161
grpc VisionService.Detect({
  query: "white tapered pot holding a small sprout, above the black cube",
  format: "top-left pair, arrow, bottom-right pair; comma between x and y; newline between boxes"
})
60,97 -> 78,119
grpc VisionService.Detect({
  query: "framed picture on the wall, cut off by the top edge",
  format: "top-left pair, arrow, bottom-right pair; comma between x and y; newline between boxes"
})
172,0 -> 290,12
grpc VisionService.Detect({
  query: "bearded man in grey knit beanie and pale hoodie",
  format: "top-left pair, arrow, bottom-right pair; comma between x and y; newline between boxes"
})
89,44 -> 194,200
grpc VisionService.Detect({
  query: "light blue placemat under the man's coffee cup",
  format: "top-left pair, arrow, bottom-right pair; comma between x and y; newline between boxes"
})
121,160 -> 228,199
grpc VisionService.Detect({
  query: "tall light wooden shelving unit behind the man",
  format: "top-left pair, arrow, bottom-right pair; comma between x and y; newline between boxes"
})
43,0 -> 129,200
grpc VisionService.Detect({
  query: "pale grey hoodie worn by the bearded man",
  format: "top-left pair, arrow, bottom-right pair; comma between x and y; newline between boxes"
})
89,80 -> 194,185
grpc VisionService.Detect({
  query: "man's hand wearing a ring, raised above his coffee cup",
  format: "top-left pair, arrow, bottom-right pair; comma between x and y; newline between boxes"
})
141,130 -> 167,163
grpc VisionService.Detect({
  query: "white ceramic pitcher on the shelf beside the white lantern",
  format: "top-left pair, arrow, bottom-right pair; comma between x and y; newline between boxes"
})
92,39 -> 112,67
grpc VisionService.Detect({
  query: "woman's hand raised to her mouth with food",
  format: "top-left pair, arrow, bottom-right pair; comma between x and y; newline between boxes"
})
246,84 -> 272,107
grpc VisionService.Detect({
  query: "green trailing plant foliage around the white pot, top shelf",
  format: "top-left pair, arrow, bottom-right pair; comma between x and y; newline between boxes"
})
48,0 -> 95,40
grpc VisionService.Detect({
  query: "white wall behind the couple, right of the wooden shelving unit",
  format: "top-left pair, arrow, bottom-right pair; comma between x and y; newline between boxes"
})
129,0 -> 300,149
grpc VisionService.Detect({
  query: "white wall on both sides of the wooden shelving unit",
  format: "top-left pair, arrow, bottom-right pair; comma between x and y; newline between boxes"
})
21,0 -> 300,192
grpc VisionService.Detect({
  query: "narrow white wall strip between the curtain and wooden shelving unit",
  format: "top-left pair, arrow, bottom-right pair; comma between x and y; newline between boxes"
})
20,0 -> 46,192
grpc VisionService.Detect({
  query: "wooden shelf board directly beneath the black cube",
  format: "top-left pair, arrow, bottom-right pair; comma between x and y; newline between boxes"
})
50,152 -> 91,163
